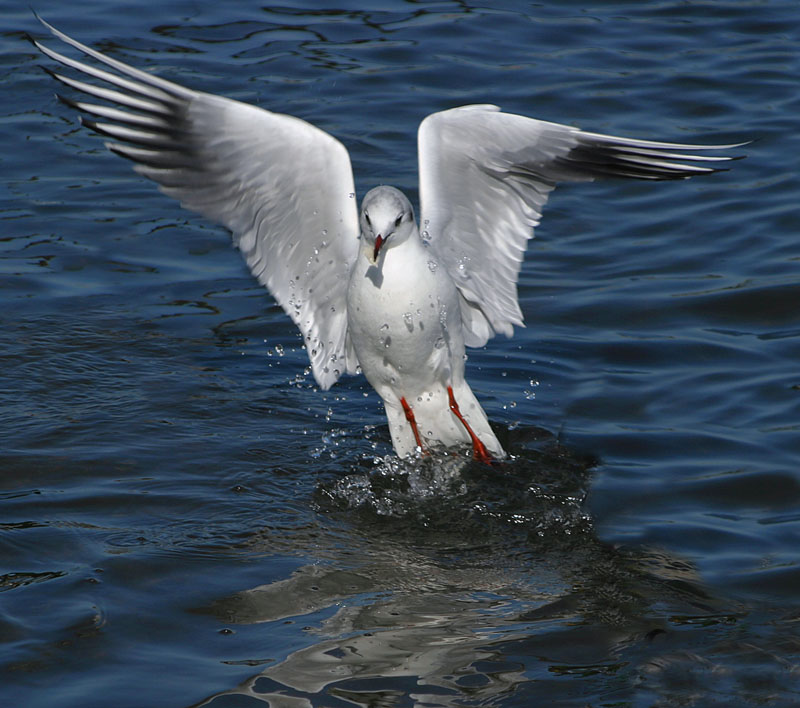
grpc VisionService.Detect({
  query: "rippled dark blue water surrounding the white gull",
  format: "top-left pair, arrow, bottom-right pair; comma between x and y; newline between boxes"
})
0,0 -> 800,708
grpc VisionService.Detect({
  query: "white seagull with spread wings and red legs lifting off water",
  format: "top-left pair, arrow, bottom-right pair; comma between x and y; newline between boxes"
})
31,16 -> 745,463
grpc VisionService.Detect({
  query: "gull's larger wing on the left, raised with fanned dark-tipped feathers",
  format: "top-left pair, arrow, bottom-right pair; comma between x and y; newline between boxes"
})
34,20 -> 359,389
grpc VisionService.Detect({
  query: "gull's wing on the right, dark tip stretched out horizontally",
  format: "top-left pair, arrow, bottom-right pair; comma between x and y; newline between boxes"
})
418,105 -> 737,347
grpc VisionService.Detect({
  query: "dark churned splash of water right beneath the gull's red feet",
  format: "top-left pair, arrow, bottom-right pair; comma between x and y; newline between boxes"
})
315,427 -> 594,543
